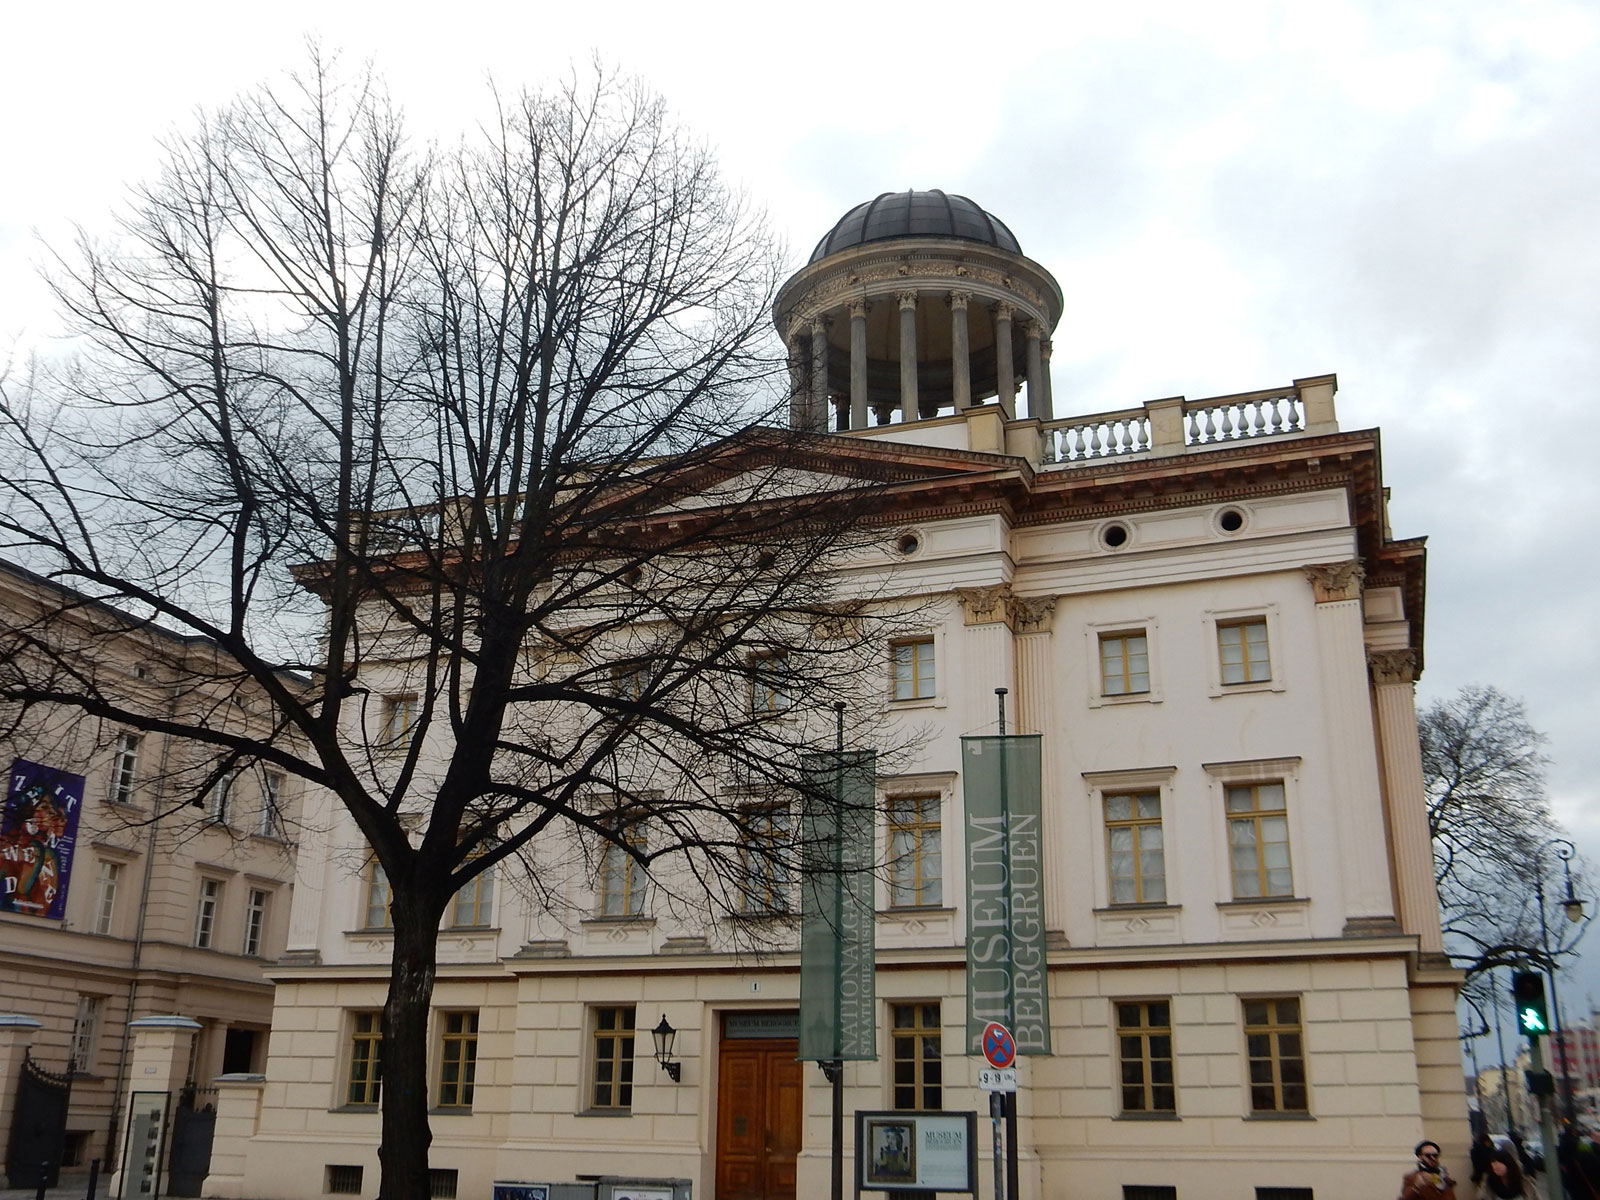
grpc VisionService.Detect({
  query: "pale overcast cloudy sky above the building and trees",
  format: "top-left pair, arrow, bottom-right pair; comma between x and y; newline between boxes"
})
0,0 -> 1600,1036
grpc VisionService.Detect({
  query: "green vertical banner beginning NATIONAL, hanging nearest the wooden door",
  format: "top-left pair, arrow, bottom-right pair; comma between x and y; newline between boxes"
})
800,750 -> 878,1062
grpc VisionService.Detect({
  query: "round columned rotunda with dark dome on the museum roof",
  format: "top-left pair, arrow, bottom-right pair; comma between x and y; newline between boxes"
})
773,190 -> 1062,432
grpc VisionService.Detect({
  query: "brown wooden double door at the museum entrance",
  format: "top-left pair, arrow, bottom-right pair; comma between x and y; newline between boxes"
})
717,1037 -> 802,1200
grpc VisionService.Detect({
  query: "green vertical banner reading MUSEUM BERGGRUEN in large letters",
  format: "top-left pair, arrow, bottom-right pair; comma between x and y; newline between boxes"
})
962,733 -> 1050,1054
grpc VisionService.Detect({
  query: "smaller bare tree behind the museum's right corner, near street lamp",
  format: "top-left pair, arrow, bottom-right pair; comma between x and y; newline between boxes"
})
1418,686 -> 1581,979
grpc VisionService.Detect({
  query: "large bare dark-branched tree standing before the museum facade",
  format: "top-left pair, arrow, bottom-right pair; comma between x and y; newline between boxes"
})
0,58 -> 921,1200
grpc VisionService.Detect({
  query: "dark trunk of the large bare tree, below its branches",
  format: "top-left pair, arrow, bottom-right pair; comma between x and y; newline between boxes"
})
378,888 -> 438,1200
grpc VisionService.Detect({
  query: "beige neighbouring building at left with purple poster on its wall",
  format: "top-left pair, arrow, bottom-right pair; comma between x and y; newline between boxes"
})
0,563 -> 301,1168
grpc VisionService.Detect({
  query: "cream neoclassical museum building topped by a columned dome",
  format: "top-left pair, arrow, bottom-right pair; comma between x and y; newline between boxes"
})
206,192 -> 1467,1200
